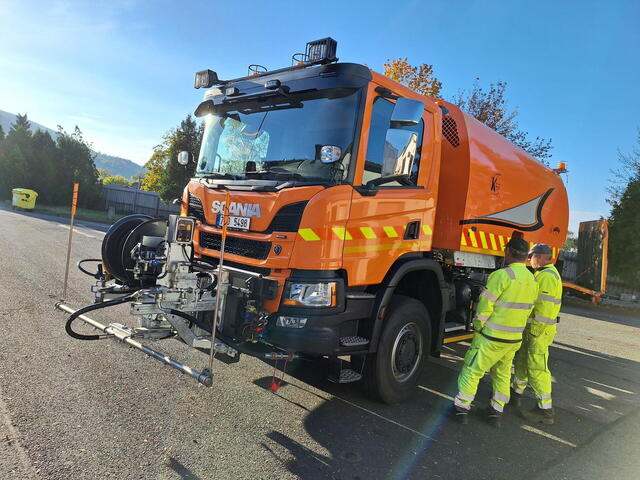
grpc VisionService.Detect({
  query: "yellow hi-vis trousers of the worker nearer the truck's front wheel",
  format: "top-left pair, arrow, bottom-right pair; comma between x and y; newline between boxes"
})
454,333 -> 520,412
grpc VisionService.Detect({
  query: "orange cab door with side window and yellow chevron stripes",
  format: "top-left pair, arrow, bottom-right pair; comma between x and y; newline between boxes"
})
343,84 -> 435,286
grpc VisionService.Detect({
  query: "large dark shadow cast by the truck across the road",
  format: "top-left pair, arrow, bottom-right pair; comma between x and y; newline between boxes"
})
255,338 -> 640,479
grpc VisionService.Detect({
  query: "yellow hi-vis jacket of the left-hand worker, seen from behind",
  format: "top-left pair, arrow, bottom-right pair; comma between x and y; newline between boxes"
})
473,262 -> 538,342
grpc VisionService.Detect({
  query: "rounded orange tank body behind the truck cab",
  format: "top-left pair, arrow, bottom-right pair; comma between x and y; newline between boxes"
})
433,101 -> 569,261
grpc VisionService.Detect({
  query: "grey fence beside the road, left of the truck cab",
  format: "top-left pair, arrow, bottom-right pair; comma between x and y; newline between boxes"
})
102,185 -> 180,218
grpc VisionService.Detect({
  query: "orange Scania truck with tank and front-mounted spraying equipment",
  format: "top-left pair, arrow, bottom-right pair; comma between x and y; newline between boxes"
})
60,38 -> 568,403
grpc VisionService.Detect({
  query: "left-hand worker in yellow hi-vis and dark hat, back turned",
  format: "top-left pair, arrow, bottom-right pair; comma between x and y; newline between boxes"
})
454,238 -> 538,427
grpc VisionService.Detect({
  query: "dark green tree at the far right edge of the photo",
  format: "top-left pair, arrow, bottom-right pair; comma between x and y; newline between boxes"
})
607,133 -> 640,283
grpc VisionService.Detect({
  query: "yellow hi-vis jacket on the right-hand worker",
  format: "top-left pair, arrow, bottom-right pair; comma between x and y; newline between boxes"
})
531,264 -> 562,334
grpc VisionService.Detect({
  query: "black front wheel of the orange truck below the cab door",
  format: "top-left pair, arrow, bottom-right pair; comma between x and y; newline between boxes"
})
364,295 -> 431,404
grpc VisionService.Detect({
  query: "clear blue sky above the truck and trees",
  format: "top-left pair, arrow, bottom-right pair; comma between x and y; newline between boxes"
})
0,0 -> 640,231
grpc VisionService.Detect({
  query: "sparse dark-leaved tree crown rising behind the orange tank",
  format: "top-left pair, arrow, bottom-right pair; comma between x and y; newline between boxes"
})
452,78 -> 553,165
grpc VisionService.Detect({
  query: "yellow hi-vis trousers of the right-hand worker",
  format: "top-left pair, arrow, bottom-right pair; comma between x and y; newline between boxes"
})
513,324 -> 556,409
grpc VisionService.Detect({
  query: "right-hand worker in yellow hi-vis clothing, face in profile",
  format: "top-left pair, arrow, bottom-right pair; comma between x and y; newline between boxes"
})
512,243 -> 562,425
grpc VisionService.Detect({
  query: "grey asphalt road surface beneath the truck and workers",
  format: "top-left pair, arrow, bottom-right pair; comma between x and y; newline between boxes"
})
0,209 -> 640,480
